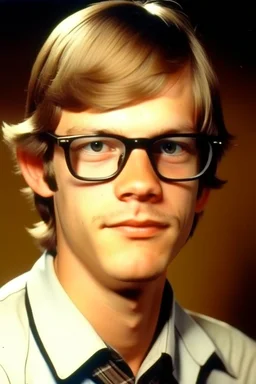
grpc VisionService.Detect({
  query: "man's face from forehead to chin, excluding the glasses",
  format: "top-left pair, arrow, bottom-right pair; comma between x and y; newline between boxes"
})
46,73 -> 206,292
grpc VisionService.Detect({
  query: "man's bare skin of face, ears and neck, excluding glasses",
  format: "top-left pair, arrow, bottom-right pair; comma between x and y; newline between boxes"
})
18,69 -> 208,374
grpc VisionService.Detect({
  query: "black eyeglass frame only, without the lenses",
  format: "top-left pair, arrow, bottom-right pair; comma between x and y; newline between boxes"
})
43,132 -> 223,182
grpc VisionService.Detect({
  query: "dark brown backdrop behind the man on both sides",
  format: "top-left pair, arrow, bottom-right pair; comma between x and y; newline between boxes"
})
0,0 -> 256,339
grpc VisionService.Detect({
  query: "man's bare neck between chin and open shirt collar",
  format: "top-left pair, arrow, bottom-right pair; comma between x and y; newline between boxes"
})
55,257 -> 165,375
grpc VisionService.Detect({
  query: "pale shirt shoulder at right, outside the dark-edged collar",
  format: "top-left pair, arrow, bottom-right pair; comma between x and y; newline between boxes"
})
186,311 -> 256,377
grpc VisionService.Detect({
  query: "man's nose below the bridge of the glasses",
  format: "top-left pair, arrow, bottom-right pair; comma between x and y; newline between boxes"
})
114,149 -> 163,203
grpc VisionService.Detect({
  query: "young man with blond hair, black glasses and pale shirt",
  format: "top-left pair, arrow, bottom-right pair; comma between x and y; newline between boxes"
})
0,0 -> 256,384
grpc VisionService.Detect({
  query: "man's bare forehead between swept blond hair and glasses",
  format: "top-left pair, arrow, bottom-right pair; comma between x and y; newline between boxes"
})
56,68 -> 195,137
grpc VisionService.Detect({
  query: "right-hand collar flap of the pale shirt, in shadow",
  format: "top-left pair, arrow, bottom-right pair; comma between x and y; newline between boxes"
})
138,281 -> 237,377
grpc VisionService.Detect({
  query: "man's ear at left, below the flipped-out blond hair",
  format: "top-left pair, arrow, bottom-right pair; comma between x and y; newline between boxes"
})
17,149 -> 54,197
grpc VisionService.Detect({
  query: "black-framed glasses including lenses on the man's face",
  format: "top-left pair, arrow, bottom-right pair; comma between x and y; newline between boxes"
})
46,132 -> 222,182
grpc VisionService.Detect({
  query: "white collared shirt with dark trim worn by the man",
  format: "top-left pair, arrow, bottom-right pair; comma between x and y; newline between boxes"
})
0,254 -> 256,384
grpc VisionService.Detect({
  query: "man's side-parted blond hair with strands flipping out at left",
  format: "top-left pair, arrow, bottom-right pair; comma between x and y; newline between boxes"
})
3,0 -> 230,251
